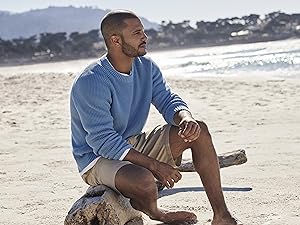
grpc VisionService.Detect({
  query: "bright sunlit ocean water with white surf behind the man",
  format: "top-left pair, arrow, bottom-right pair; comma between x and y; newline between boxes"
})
0,39 -> 300,79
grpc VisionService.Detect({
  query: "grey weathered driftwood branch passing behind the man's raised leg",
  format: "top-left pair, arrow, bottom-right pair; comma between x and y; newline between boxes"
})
178,149 -> 247,172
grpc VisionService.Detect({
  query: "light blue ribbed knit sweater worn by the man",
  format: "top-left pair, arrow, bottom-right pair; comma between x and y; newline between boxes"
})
70,55 -> 188,172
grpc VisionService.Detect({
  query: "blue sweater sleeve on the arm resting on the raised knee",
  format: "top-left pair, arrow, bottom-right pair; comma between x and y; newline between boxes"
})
152,63 -> 189,125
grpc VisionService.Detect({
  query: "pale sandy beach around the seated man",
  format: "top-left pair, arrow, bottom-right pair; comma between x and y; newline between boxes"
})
0,60 -> 300,225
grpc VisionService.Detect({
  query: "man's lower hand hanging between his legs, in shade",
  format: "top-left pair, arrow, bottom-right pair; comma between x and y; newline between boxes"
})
150,161 -> 182,188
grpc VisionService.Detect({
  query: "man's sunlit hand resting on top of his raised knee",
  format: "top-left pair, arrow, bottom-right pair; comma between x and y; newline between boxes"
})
175,111 -> 201,142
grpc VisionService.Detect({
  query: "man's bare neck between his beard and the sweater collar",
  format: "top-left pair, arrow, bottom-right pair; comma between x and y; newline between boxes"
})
107,53 -> 134,74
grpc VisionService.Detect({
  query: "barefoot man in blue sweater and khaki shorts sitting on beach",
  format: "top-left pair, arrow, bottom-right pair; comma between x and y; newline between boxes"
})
71,10 -> 241,225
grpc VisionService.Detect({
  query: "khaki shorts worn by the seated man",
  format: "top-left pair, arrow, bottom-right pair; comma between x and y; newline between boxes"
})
82,125 -> 181,192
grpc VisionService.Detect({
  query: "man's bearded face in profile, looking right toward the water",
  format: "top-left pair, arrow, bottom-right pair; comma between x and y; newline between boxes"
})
121,18 -> 147,57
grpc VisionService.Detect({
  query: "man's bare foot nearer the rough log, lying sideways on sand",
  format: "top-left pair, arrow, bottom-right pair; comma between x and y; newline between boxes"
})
151,209 -> 197,225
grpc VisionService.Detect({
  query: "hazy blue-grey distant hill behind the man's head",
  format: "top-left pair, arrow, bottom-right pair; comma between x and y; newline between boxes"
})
0,6 -> 159,39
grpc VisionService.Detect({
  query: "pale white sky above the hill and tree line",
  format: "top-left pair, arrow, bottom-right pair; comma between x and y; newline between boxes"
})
0,0 -> 300,25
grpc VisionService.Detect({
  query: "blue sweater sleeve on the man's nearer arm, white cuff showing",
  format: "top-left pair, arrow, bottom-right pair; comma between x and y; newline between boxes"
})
71,76 -> 132,160
